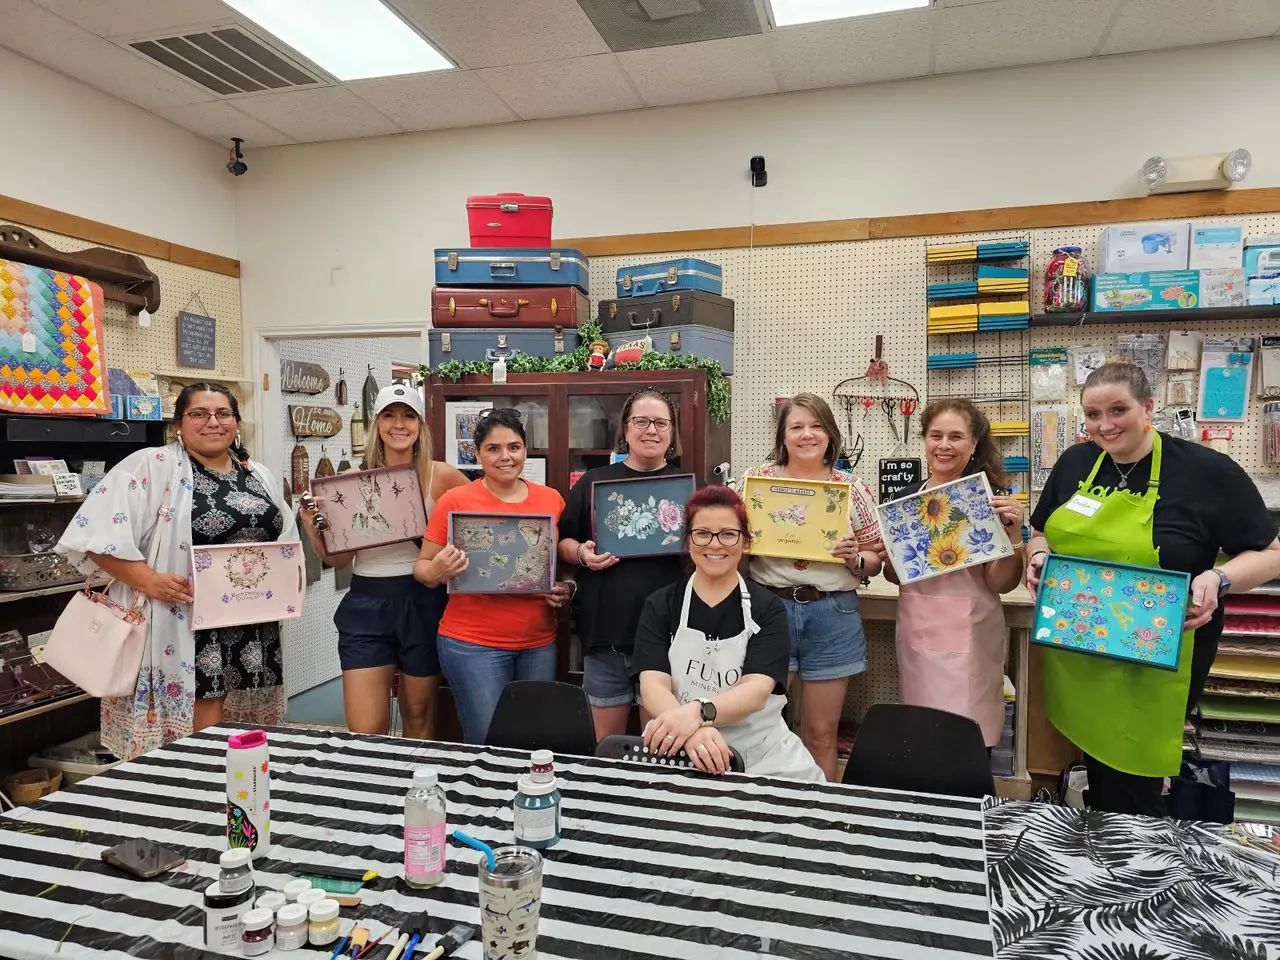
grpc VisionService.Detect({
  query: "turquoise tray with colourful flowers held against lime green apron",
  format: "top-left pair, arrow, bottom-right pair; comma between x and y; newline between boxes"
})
1032,554 -> 1190,669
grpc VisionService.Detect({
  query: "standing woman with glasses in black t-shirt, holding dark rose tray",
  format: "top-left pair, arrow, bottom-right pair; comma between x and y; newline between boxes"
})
559,387 -> 689,740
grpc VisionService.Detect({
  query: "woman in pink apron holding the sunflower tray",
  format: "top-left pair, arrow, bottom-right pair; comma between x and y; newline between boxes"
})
881,399 -> 1025,748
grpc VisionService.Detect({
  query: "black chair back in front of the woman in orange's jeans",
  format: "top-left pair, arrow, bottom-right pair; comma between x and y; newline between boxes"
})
485,680 -> 595,756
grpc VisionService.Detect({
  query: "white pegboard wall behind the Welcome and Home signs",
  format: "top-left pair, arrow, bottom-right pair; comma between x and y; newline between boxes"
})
275,335 -> 421,696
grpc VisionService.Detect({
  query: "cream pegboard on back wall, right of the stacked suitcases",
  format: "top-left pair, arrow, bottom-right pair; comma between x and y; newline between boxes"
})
590,214 -> 1280,504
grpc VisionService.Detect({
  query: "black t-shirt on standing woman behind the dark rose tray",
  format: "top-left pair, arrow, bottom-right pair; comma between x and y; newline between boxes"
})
559,463 -> 689,650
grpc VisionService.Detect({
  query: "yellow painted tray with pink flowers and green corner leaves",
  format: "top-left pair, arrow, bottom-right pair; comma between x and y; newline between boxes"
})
742,476 -> 850,563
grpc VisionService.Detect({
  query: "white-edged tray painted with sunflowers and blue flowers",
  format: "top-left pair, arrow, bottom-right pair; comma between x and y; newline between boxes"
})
877,474 -> 1014,584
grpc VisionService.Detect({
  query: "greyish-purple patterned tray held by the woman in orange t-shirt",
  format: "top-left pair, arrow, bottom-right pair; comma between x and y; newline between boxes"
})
449,511 -> 556,594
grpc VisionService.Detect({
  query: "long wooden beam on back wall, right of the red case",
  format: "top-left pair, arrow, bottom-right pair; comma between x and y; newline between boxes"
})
554,187 -> 1280,257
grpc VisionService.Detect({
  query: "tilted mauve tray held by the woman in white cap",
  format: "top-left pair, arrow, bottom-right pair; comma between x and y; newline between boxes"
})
311,463 -> 426,553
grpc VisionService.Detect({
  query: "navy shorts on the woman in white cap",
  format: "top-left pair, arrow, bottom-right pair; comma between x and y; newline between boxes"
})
333,575 -> 448,677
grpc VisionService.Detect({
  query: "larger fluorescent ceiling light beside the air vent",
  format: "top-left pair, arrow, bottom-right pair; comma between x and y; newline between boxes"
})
224,0 -> 453,81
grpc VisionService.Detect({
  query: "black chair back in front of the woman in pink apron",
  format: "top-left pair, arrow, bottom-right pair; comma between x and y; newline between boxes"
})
842,703 -> 996,797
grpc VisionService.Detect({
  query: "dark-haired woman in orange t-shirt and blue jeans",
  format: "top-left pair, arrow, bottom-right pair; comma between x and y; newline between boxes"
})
413,410 -> 573,744
